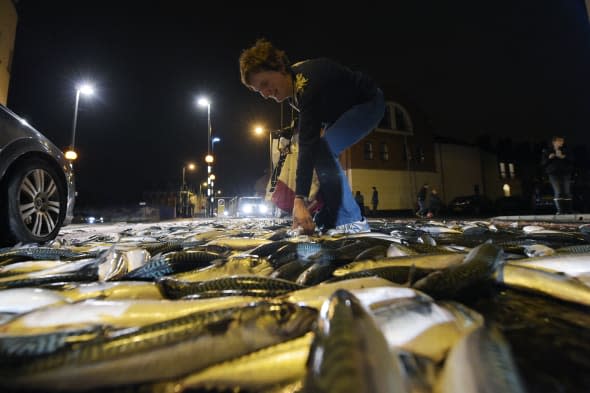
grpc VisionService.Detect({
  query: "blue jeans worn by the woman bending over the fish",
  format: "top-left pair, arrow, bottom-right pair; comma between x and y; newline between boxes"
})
314,90 -> 385,228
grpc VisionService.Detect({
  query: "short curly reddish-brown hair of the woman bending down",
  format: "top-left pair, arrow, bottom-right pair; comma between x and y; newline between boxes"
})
240,38 -> 289,87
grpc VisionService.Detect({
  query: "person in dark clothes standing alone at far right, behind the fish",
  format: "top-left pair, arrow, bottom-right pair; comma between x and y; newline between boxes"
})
541,136 -> 573,214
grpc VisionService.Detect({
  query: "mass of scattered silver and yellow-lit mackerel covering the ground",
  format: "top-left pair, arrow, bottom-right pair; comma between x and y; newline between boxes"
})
0,219 -> 590,393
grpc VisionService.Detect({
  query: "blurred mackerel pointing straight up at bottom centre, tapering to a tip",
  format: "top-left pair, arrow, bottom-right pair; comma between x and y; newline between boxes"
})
303,289 -> 406,393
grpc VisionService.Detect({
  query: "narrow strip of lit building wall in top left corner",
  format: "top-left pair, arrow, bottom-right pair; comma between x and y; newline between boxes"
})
0,0 -> 17,105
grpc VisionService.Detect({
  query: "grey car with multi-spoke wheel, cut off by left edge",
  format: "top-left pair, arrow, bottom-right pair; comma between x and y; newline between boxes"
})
0,104 -> 76,245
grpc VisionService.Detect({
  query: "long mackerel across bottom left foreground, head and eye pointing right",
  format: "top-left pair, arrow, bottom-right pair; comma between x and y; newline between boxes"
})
0,302 -> 317,391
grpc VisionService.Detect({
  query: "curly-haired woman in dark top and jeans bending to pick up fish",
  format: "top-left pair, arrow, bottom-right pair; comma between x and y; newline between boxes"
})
239,38 -> 385,234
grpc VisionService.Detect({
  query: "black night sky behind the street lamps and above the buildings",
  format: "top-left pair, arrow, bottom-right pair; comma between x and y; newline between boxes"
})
8,0 -> 590,206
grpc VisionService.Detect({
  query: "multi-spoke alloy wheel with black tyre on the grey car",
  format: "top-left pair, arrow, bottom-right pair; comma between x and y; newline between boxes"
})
3,159 -> 67,243
